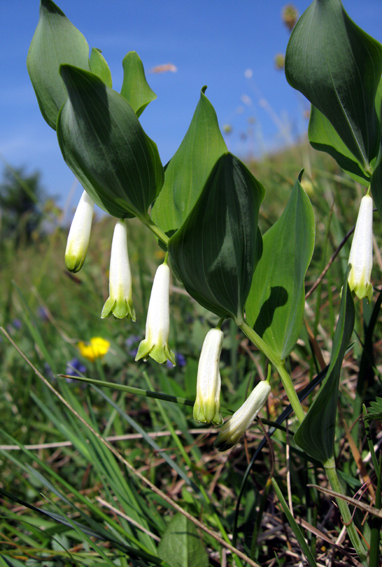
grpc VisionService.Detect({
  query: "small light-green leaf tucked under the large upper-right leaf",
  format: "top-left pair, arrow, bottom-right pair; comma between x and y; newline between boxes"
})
308,105 -> 370,186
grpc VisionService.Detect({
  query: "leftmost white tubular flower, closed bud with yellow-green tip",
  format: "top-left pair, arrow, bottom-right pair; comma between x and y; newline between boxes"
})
65,191 -> 94,272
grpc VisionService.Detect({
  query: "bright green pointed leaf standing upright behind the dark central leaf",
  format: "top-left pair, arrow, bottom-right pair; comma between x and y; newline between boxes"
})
152,87 -> 227,233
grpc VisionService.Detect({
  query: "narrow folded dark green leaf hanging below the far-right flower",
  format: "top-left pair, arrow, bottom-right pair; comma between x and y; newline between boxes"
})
294,273 -> 354,462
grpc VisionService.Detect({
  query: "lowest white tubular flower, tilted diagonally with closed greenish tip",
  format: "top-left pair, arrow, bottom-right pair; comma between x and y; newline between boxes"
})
215,381 -> 271,451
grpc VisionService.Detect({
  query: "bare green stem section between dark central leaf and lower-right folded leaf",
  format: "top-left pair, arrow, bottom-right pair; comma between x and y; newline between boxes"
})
238,321 -> 305,423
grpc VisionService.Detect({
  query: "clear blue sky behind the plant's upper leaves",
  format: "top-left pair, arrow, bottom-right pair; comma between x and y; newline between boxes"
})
0,0 -> 382,215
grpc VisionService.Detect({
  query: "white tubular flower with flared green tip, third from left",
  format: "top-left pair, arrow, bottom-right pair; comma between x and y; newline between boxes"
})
135,264 -> 175,366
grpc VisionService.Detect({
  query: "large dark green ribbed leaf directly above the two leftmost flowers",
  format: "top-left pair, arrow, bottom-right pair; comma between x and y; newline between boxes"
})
57,65 -> 163,218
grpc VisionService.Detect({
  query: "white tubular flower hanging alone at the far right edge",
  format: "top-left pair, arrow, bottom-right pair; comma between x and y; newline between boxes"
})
348,195 -> 373,301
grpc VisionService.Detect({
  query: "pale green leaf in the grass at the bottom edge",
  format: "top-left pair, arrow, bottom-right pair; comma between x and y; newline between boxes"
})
158,513 -> 208,567
